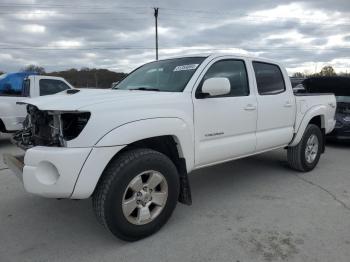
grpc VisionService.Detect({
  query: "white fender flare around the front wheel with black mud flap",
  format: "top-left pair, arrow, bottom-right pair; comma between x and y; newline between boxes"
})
71,118 -> 194,199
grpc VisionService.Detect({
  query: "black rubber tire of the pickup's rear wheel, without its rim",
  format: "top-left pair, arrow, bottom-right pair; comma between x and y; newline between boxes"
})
287,124 -> 324,172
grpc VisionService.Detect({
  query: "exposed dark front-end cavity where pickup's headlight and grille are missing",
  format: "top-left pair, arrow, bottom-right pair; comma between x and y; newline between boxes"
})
12,104 -> 91,150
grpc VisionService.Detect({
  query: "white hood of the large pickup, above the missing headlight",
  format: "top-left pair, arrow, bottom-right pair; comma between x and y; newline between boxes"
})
21,89 -> 169,111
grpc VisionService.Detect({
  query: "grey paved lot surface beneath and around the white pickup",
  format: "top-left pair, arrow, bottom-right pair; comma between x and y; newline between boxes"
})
0,136 -> 350,262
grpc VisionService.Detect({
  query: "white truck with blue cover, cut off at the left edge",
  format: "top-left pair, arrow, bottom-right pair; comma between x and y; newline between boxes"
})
0,73 -> 72,133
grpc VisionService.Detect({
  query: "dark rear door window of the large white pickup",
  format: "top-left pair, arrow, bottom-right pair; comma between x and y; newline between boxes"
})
253,62 -> 286,95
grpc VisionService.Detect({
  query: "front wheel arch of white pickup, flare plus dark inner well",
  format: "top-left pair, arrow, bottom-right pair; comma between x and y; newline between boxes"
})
72,118 -> 194,204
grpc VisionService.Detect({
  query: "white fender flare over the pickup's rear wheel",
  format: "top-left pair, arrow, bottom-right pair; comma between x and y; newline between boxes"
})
289,105 -> 327,147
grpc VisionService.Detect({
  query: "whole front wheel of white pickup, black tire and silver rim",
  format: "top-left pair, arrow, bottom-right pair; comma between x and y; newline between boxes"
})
93,149 -> 180,241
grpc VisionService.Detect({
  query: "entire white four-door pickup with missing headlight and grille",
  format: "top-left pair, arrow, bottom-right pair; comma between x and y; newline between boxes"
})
5,55 -> 336,241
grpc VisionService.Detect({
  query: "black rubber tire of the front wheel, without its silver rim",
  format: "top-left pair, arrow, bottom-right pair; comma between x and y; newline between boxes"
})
92,149 -> 180,241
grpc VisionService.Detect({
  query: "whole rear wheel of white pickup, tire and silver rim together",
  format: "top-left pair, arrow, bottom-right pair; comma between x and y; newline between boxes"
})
287,124 -> 324,172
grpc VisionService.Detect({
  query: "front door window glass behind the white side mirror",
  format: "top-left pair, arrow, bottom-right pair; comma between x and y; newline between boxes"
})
197,60 -> 249,97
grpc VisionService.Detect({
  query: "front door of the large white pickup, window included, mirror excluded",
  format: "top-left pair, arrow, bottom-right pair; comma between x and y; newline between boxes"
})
193,58 -> 257,167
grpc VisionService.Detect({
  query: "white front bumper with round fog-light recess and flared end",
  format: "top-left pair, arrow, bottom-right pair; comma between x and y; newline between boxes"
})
4,146 -> 124,199
